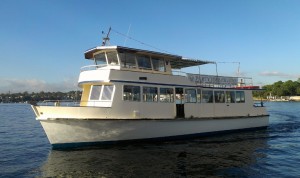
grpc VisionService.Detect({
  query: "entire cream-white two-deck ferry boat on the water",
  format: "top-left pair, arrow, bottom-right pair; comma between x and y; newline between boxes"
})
32,40 -> 269,147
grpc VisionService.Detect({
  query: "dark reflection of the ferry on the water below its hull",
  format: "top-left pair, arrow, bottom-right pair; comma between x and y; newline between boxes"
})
40,130 -> 269,177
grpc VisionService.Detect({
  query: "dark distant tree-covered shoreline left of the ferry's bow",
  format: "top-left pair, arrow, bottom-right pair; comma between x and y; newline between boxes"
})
0,91 -> 82,103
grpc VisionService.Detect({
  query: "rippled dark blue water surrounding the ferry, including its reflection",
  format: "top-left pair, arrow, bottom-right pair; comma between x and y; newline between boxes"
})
0,102 -> 300,177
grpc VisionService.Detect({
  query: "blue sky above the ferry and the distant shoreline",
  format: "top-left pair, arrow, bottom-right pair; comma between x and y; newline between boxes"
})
0,0 -> 300,93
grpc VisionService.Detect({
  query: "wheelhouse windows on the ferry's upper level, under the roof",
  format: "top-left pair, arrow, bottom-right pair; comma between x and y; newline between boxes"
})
94,51 -> 166,72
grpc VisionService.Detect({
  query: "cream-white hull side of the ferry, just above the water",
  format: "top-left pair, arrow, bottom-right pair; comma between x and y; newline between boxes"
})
40,116 -> 269,147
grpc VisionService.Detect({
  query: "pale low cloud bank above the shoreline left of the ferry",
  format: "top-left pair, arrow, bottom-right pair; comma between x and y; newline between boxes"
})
0,78 -> 79,93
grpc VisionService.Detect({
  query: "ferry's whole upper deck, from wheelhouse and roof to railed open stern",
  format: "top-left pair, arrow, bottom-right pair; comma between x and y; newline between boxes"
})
79,46 -> 258,90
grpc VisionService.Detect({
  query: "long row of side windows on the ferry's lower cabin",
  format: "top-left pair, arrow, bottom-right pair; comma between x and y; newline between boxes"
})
123,85 -> 245,103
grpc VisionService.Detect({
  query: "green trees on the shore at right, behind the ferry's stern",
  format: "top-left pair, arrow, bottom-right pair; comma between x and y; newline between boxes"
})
253,79 -> 300,98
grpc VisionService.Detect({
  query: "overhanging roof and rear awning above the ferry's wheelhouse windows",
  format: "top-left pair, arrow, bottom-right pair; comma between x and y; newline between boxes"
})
84,46 -> 215,69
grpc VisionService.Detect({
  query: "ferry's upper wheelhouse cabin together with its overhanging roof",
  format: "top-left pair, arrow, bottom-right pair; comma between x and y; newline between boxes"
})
82,46 -> 214,75
